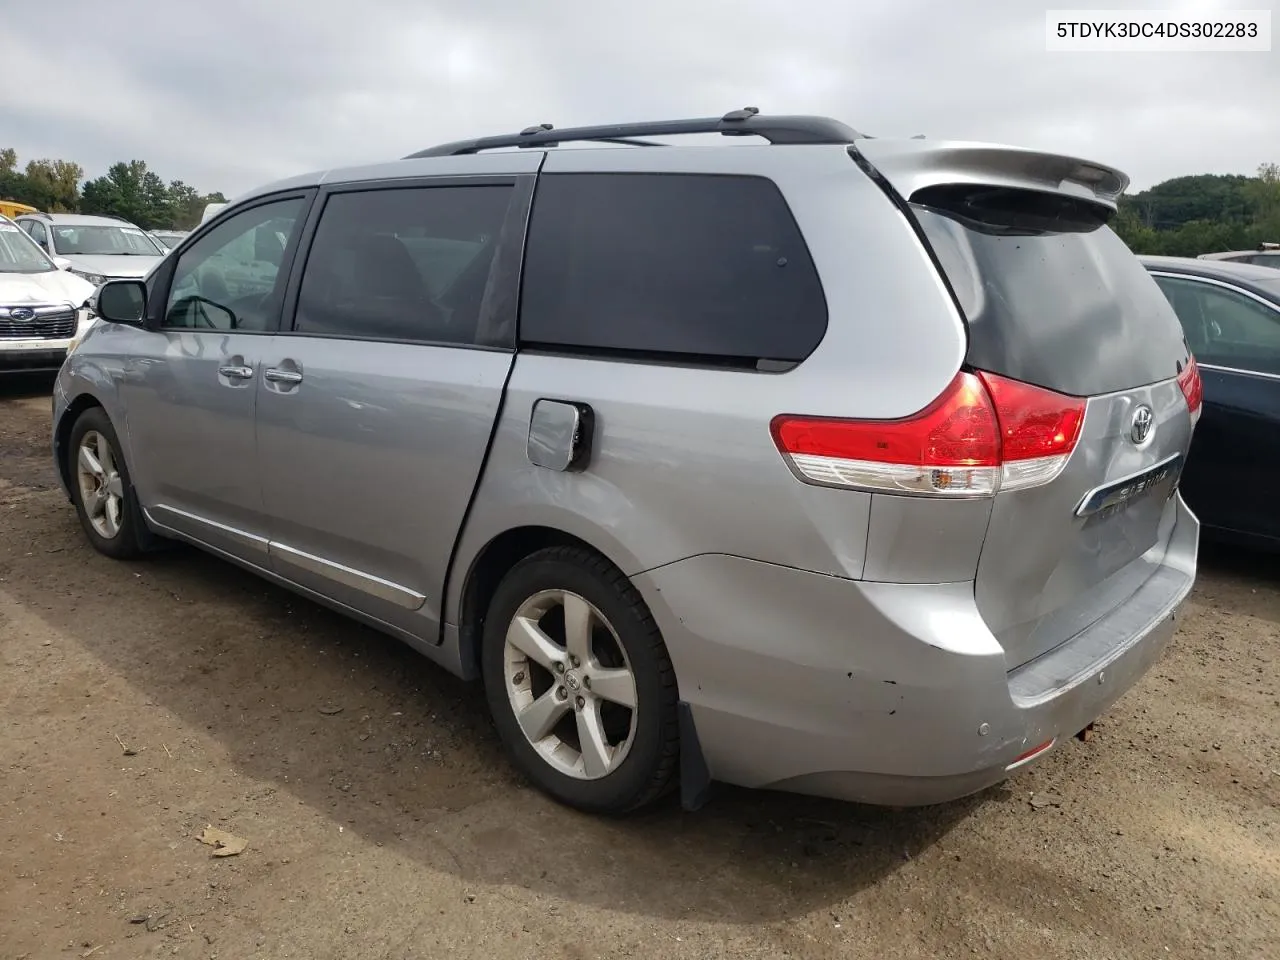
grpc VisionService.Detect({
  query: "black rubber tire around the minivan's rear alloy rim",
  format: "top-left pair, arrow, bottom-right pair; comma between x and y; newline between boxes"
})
481,547 -> 680,814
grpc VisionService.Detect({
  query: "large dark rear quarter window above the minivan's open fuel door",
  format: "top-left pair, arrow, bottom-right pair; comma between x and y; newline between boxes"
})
520,174 -> 827,365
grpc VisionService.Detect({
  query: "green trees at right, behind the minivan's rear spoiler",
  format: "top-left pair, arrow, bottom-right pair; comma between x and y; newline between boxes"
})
1111,164 -> 1280,257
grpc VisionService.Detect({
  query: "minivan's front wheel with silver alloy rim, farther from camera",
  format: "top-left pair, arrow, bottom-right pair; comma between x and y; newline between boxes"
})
67,407 -> 146,559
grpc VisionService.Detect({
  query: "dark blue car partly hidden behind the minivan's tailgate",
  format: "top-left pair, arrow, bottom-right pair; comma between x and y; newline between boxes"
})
1142,257 -> 1280,549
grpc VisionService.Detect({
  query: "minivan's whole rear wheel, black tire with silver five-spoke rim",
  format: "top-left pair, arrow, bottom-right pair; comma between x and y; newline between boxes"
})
483,547 -> 680,813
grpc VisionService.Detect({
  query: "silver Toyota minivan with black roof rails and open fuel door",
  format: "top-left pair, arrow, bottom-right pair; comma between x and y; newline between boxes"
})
54,109 -> 1201,813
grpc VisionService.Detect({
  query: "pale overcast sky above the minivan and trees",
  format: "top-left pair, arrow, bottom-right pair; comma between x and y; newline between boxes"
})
0,0 -> 1280,196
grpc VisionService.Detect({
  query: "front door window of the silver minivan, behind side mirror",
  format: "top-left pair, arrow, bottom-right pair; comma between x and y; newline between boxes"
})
163,197 -> 305,330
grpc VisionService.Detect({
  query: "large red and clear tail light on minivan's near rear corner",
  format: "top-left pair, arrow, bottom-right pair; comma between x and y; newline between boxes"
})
771,371 -> 1084,497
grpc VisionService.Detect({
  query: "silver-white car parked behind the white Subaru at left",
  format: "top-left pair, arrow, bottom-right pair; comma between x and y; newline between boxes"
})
15,214 -> 166,287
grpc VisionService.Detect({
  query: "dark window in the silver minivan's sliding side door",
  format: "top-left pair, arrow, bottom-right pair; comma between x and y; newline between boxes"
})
294,187 -> 511,343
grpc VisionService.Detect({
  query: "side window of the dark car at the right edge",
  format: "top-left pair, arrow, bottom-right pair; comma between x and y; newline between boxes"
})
1156,276 -> 1280,374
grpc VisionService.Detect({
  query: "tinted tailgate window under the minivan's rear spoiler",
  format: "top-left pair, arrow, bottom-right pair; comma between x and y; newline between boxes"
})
911,186 -> 1187,397
